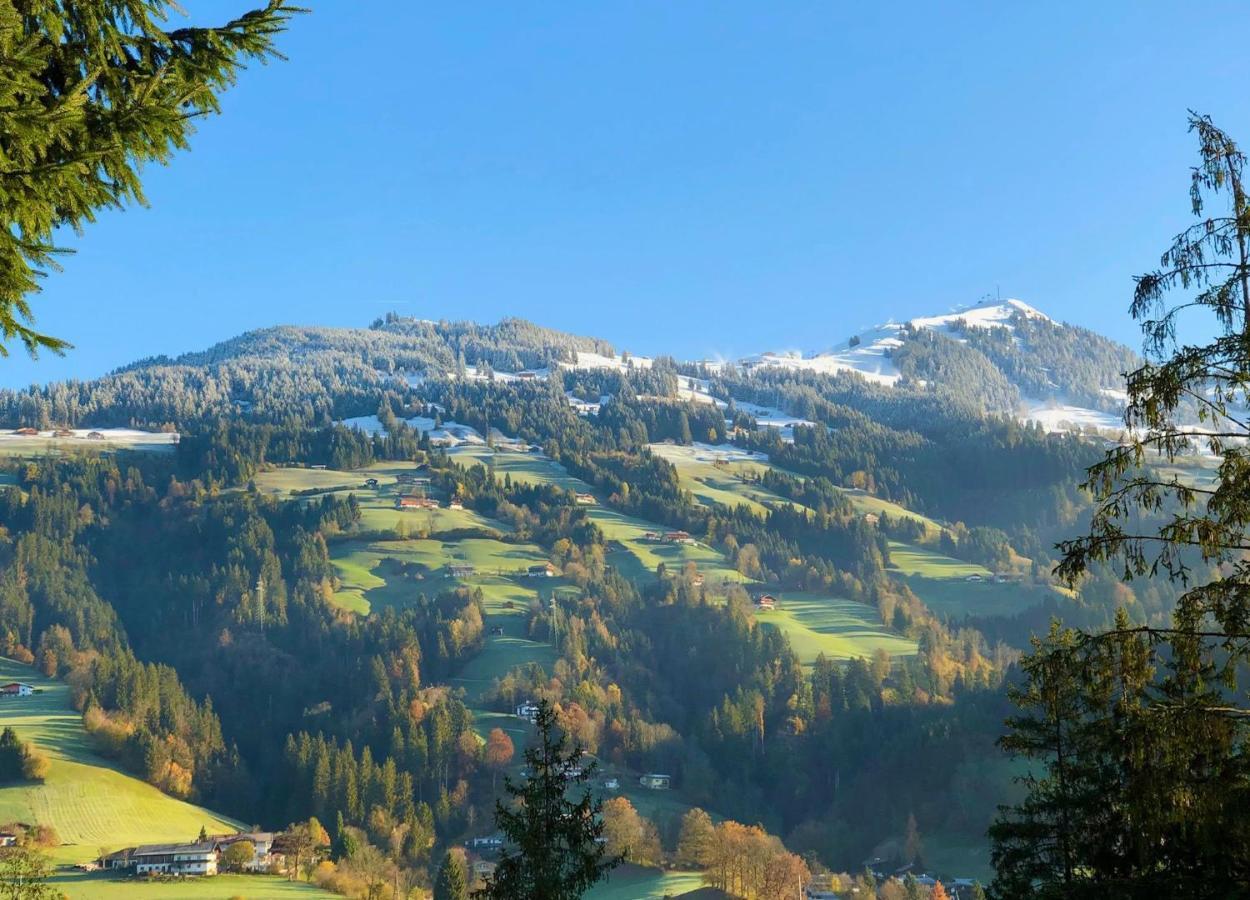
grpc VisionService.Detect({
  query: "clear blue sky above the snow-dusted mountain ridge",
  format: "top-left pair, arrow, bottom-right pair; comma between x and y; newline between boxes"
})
0,0 -> 1250,386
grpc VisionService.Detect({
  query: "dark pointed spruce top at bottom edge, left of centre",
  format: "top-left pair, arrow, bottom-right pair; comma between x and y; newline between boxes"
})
474,700 -> 621,900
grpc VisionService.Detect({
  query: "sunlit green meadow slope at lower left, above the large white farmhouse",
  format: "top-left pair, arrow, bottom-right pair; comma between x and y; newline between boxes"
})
0,659 -> 239,861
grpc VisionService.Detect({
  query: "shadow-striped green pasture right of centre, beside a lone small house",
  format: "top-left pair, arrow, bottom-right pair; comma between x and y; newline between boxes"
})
755,591 -> 916,665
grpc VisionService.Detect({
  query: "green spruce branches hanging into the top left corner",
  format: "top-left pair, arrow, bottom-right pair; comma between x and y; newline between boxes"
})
0,0 -> 300,355
